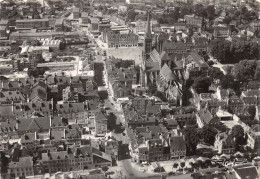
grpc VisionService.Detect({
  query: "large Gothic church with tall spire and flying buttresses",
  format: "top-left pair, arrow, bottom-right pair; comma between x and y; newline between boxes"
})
140,12 -> 185,105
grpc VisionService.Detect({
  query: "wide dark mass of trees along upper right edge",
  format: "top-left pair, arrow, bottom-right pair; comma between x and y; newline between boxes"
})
210,39 -> 259,64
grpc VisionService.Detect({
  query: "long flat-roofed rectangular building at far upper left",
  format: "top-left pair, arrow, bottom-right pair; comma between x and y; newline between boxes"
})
16,19 -> 49,29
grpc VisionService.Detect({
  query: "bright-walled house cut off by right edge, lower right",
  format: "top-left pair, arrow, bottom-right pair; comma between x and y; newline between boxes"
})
247,125 -> 260,152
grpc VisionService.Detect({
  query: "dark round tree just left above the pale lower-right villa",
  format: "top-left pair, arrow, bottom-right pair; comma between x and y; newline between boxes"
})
200,125 -> 218,145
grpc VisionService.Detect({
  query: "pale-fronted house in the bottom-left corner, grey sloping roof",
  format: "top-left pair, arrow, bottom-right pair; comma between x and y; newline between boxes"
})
8,157 -> 34,178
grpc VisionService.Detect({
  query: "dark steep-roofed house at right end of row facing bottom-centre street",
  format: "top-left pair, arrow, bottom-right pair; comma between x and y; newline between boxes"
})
169,136 -> 186,159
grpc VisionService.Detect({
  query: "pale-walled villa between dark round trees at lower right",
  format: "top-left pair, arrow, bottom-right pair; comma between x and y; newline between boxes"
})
214,133 -> 235,154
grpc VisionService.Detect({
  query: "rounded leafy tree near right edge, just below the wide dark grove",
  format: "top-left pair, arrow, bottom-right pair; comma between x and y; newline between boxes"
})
233,60 -> 257,82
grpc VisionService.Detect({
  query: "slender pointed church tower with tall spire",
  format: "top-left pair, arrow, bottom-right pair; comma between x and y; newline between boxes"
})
143,11 -> 152,60
